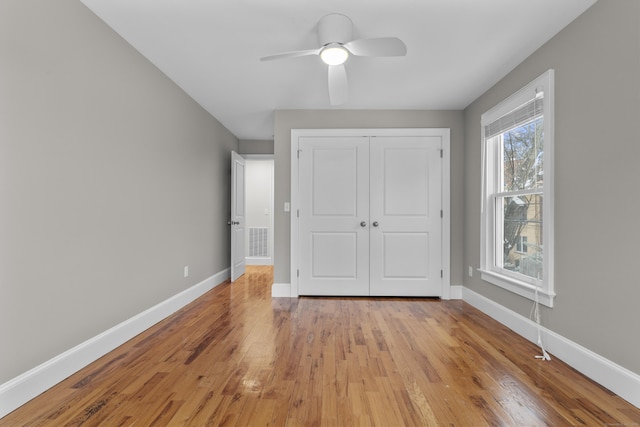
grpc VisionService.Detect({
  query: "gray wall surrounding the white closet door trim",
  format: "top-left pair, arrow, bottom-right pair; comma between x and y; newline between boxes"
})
274,109 -> 464,285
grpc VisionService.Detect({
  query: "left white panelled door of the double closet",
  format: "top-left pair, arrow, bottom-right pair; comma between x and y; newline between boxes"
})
298,137 -> 369,295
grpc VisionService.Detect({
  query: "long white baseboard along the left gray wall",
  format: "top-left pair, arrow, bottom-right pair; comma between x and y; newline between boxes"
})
0,268 -> 230,418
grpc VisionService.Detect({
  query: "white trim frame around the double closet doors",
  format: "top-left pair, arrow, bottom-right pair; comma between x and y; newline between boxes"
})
290,128 -> 451,300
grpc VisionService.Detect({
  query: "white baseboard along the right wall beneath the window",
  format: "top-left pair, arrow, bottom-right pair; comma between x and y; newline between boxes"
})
462,288 -> 640,408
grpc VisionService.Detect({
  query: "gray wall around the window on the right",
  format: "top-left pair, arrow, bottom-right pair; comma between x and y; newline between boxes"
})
464,0 -> 640,374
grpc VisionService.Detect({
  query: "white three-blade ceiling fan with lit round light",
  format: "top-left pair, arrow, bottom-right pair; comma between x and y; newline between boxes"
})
260,13 -> 407,105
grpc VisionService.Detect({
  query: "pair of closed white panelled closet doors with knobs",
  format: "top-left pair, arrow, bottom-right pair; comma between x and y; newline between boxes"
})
298,136 -> 442,296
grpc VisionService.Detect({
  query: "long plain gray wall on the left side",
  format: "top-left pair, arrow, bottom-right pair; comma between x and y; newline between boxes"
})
0,0 -> 238,383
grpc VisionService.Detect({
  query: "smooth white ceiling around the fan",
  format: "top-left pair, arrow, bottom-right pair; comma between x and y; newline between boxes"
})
81,0 -> 596,140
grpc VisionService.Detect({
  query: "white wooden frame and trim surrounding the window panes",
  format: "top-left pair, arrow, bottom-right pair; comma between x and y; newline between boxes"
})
480,69 -> 555,307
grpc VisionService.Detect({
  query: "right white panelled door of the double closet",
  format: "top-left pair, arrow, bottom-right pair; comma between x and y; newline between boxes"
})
370,137 -> 442,296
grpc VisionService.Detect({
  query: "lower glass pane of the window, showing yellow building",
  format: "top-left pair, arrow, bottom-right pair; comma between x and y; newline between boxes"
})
496,193 -> 543,279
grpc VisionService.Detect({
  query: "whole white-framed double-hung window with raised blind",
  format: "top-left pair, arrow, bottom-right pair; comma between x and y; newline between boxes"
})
480,70 -> 555,307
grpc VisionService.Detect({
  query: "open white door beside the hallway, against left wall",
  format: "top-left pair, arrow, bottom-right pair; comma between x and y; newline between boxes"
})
230,151 -> 245,282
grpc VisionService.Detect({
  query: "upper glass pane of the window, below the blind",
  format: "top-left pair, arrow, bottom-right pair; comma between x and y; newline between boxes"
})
502,116 -> 543,192
